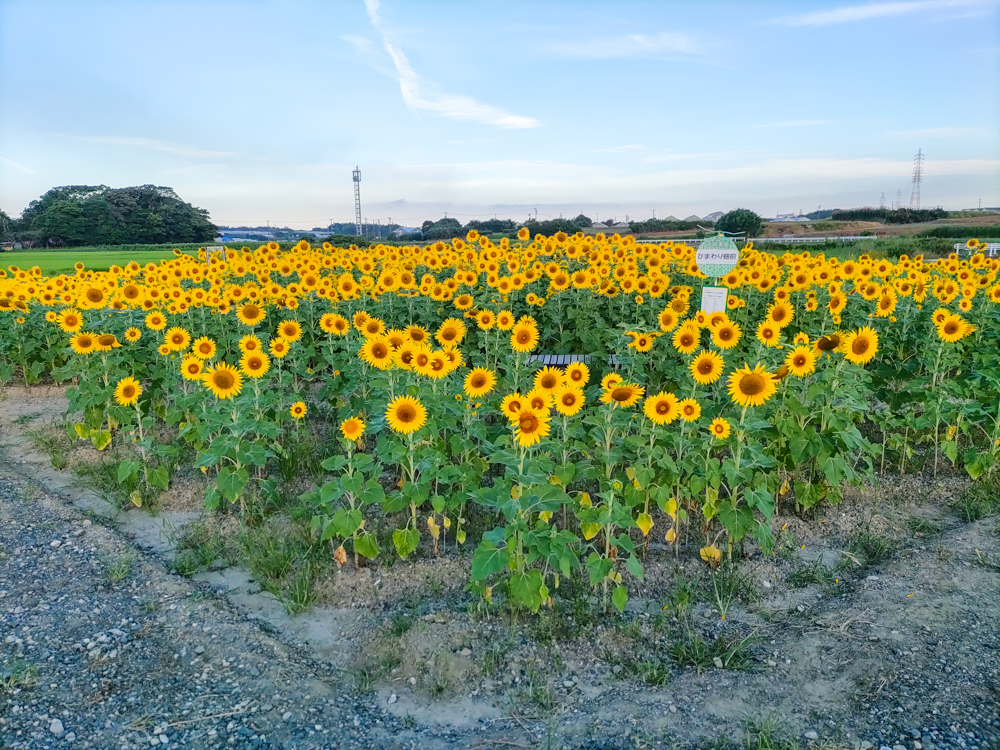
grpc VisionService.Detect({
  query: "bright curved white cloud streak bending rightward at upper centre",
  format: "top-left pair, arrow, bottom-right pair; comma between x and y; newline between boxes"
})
365,0 -> 540,129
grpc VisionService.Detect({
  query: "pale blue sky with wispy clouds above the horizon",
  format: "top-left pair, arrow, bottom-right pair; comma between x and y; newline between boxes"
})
0,0 -> 1000,228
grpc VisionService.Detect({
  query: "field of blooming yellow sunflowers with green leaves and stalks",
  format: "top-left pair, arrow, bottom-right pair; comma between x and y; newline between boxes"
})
0,235 -> 1000,611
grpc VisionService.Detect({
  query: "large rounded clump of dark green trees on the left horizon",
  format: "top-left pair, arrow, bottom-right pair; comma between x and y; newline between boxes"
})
0,185 -> 217,247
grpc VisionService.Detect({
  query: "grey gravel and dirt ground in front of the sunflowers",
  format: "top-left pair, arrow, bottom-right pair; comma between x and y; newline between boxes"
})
0,389 -> 1000,750
